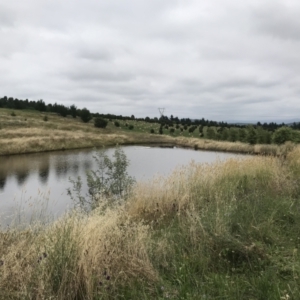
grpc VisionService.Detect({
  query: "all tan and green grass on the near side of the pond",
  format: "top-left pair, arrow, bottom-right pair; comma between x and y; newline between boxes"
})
0,147 -> 300,300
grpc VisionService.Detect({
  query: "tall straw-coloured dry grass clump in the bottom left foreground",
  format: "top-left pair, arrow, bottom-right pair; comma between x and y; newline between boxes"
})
0,208 -> 157,299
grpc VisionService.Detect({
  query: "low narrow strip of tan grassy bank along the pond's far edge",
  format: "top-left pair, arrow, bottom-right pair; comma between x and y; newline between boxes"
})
0,128 -> 294,156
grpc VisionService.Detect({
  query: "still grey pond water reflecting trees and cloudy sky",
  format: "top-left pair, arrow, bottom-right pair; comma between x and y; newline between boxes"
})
0,146 -> 243,226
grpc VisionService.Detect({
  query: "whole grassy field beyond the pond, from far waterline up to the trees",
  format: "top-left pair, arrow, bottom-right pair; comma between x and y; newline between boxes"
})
0,108 -> 293,155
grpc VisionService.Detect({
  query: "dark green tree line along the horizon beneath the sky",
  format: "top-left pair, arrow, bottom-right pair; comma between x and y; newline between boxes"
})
0,96 -> 300,144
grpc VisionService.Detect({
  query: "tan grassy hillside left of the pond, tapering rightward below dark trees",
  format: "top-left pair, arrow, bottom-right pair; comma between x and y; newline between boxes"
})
0,109 -> 173,155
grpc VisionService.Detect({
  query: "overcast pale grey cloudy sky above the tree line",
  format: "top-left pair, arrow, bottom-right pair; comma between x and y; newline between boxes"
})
0,0 -> 300,122
